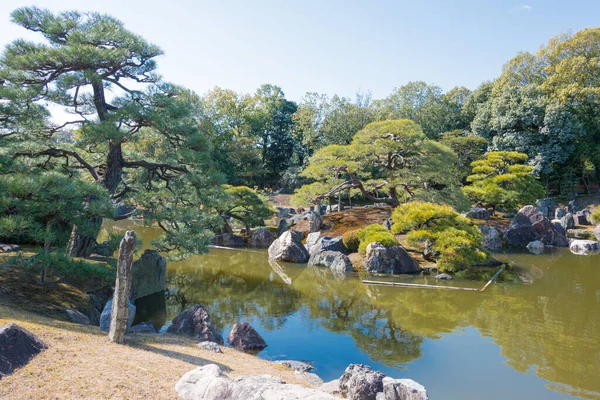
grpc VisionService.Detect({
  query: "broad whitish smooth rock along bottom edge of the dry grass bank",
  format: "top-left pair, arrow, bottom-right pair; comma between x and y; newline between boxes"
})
175,364 -> 336,400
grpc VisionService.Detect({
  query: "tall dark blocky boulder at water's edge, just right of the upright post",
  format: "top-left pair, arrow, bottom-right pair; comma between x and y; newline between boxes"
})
131,250 -> 167,299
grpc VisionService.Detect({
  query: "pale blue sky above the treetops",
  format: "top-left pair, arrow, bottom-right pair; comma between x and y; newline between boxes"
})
0,0 -> 600,100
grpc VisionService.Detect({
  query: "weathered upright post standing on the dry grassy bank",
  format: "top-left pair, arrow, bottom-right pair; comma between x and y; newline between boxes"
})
108,231 -> 135,343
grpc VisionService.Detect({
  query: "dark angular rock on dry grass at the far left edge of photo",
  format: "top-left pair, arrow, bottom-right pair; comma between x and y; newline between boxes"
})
0,323 -> 48,379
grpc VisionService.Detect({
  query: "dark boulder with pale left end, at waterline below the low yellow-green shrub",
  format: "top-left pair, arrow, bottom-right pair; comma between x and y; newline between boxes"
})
365,242 -> 421,274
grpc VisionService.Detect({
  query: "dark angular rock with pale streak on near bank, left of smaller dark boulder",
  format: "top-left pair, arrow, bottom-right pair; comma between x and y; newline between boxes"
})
167,304 -> 223,344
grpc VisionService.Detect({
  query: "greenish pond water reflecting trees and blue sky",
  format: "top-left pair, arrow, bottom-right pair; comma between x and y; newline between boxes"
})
103,221 -> 600,400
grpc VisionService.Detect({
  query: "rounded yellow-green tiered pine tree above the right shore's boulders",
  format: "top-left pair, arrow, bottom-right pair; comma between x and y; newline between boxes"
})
464,151 -> 544,209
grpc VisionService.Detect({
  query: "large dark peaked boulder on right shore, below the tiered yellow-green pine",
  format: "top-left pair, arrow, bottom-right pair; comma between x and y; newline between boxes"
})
504,206 -> 569,247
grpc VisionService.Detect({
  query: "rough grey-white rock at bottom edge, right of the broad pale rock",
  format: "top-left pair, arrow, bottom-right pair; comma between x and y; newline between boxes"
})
340,364 -> 385,400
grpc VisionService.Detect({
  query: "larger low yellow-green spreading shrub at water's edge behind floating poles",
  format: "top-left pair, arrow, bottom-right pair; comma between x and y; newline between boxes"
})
392,201 -> 489,272
